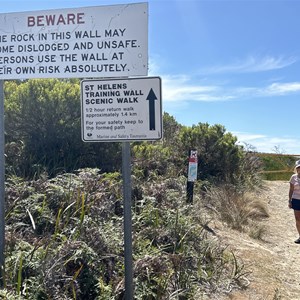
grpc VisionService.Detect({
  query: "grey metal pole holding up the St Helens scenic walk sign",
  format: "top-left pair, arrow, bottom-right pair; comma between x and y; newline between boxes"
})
122,142 -> 133,300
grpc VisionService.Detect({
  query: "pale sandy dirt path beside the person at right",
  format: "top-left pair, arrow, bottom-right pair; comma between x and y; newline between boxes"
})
218,181 -> 300,300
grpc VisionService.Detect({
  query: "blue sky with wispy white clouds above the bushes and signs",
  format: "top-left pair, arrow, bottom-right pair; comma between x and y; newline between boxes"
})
0,0 -> 300,154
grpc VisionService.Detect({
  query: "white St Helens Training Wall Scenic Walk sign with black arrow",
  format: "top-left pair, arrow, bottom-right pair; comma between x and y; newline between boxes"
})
81,77 -> 162,142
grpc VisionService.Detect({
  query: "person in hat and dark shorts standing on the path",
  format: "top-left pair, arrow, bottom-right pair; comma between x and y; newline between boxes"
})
288,160 -> 300,244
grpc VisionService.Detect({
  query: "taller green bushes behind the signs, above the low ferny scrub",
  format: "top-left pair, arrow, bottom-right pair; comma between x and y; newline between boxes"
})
4,79 -> 259,183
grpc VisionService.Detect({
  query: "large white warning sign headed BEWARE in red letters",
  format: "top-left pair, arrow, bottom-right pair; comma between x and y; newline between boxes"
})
0,3 -> 148,80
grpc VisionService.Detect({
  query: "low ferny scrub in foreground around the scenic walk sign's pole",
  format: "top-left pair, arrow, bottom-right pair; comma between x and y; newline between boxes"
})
3,169 -> 250,300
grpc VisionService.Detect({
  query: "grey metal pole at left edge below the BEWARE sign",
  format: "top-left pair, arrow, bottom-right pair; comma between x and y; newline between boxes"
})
0,80 -> 5,287
